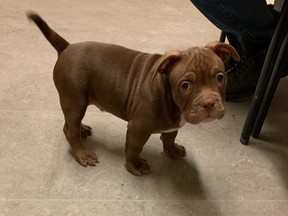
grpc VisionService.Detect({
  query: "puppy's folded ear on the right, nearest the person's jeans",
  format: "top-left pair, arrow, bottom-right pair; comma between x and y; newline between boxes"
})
205,41 -> 240,62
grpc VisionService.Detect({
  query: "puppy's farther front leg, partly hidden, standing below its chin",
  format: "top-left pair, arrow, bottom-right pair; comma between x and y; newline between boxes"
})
160,130 -> 186,159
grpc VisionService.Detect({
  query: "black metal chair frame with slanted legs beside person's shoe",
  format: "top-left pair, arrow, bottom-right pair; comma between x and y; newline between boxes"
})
219,0 -> 288,145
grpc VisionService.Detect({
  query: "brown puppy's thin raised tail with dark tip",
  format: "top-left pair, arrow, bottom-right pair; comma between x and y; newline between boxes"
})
27,12 -> 69,55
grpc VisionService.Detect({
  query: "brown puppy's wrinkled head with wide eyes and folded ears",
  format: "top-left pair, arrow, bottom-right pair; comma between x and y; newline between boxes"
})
154,42 -> 240,124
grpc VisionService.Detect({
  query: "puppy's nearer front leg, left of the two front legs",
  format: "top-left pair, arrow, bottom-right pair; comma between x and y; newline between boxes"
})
125,123 -> 151,176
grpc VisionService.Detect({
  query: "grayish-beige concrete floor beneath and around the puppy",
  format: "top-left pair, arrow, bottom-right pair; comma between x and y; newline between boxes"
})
0,0 -> 288,216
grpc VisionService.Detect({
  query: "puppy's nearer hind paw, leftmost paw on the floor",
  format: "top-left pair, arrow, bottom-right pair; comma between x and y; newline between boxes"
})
72,148 -> 99,167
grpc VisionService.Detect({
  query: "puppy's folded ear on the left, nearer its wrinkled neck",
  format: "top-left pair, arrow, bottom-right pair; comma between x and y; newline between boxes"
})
152,50 -> 182,80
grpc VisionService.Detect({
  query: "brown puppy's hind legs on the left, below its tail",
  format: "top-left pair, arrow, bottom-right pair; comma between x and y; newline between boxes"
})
60,95 -> 98,167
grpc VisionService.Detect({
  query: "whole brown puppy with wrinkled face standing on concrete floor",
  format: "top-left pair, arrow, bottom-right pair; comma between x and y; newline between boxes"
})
28,13 -> 239,176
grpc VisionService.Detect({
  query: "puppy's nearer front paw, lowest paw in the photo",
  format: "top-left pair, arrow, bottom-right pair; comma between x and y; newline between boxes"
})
125,158 -> 150,176
